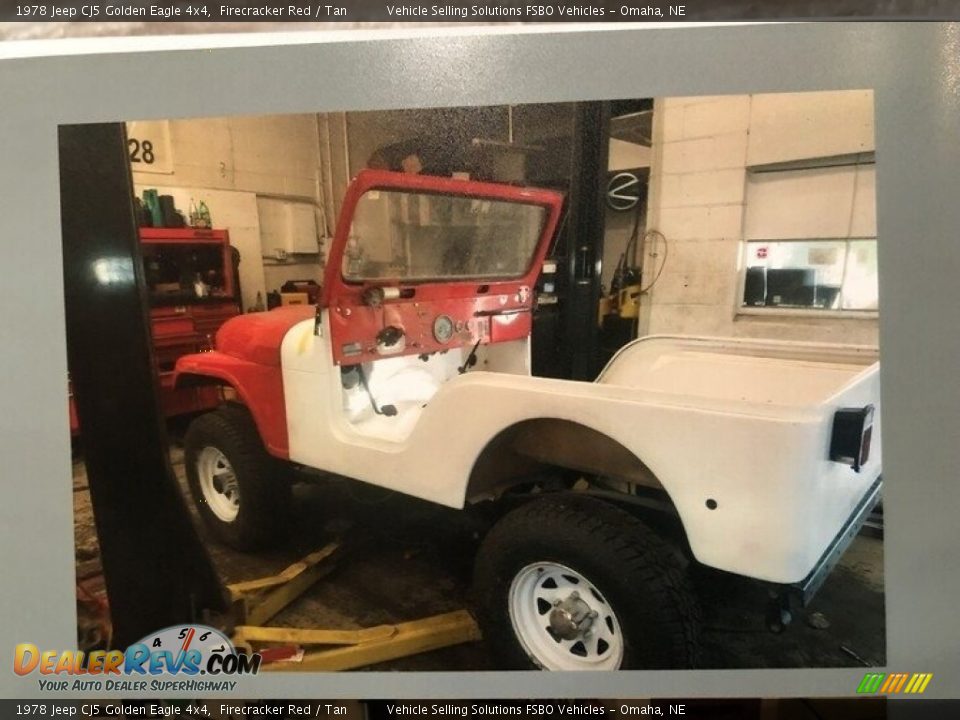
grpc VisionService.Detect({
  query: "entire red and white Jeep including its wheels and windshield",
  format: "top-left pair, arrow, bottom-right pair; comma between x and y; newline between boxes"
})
176,170 -> 881,670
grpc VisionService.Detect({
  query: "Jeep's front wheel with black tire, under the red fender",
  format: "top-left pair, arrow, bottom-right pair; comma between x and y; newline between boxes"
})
184,405 -> 290,552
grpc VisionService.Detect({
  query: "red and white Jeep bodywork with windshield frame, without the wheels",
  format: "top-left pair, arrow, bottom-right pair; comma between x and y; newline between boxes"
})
177,172 -> 881,584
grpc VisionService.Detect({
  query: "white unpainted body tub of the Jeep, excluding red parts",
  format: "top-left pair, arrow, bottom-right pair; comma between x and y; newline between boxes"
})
282,320 -> 880,583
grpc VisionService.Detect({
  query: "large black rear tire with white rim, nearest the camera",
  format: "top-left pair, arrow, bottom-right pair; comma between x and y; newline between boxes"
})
474,494 -> 700,670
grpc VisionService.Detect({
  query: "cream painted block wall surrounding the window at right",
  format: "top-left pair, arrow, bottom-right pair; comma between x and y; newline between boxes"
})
640,91 -> 877,344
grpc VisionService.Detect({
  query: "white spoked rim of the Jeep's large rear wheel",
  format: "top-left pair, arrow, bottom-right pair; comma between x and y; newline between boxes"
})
508,562 -> 624,670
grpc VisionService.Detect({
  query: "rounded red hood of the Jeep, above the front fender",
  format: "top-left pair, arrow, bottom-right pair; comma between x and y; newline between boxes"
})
217,305 -> 315,367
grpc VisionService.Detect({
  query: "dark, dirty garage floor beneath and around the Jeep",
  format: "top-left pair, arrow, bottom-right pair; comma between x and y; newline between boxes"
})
74,447 -> 886,670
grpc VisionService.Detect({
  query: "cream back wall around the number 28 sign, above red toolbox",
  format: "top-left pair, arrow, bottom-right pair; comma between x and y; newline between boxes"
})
131,115 -> 328,307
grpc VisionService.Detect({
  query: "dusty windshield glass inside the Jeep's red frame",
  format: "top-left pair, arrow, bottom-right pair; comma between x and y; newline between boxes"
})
342,190 -> 547,282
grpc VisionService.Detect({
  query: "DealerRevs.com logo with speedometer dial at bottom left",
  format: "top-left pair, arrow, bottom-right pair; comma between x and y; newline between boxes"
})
13,625 -> 261,692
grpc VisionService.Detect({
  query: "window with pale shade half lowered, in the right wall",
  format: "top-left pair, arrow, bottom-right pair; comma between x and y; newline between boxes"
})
741,155 -> 878,312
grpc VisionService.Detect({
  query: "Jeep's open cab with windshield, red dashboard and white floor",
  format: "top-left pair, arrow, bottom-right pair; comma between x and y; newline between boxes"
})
328,178 -> 558,441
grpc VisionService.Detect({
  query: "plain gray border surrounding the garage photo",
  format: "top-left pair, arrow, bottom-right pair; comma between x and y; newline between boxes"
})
0,23 -> 960,698
